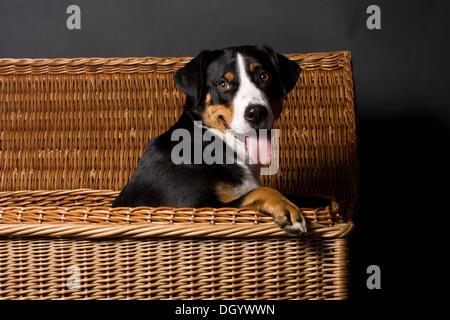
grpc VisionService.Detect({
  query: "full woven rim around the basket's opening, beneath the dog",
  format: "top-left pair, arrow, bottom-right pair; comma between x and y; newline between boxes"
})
0,189 -> 353,239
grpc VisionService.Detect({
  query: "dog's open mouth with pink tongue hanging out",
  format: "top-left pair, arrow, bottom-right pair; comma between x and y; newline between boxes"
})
219,116 -> 272,166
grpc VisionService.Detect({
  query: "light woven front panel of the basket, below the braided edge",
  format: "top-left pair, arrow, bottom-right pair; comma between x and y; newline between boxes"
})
0,238 -> 347,300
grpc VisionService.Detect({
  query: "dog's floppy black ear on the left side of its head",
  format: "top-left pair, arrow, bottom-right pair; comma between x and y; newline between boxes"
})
174,50 -> 219,105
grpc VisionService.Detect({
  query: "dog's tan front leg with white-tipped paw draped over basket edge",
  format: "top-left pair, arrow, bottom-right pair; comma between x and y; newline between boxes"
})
225,187 -> 306,235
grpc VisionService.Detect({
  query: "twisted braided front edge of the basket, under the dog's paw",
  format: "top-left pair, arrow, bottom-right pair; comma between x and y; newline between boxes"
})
0,221 -> 354,239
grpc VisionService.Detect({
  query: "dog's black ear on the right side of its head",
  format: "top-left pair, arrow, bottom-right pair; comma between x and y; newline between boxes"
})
258,45 -> 300,98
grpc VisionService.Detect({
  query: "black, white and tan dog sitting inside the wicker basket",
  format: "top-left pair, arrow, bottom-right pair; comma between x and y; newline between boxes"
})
112,45 -> 307,235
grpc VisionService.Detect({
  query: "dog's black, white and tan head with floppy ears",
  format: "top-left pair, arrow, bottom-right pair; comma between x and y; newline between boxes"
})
175,45 -> 300,164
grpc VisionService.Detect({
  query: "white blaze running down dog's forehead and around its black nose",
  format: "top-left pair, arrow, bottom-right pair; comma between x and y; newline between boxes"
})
230,53 -> 274,134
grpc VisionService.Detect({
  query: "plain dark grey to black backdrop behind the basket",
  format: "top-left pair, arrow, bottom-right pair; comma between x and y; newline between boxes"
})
0,0 -> 450,310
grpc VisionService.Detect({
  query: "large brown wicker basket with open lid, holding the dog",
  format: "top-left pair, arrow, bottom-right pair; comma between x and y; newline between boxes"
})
0,52 -> 358,299
